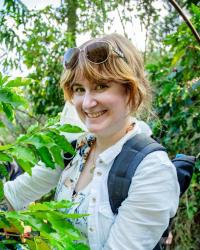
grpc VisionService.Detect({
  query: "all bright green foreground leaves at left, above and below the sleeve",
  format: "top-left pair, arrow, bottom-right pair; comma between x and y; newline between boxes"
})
0,74 -> 88,250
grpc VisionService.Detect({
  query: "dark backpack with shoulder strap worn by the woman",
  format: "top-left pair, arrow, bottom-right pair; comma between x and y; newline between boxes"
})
64,134 -> 196,250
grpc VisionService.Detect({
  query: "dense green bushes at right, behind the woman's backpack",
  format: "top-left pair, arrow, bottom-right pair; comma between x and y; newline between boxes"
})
146,6 -> 200,250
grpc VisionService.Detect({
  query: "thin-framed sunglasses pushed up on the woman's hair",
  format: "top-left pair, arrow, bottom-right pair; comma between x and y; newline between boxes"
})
63,41 -> 127,69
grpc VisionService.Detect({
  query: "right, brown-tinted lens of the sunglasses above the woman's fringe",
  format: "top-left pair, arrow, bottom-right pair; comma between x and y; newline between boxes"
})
85,42 -> 109,64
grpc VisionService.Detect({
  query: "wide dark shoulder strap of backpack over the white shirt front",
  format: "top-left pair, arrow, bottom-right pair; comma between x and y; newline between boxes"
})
107,134 -> 165,214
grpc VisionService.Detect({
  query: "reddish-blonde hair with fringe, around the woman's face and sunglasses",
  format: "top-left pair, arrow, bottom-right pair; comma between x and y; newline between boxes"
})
61,33 -> 152,117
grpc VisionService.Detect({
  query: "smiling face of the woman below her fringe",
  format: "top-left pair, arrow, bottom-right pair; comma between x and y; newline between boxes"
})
72,79 -> 129,137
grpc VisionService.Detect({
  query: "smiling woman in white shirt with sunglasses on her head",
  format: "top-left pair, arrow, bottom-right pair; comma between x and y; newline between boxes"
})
1,34 -> 179,250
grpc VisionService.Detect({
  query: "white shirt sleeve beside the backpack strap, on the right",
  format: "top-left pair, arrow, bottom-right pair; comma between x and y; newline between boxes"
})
103,152 -> 179,250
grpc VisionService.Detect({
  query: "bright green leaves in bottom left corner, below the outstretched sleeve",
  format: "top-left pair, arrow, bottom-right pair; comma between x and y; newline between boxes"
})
0,201 -> 89,250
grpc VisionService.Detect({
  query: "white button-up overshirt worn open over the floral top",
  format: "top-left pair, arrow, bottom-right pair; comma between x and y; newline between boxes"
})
4,102 -> 179,250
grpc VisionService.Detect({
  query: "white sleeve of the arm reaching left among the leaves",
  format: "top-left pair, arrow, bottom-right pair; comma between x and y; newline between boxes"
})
4,163 -> 62,210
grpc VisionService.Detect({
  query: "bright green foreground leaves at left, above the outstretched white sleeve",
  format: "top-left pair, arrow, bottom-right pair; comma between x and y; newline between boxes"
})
0,73 -> 82,177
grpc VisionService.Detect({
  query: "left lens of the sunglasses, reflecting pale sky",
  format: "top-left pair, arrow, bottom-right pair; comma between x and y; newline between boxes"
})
63,48 -> 79,69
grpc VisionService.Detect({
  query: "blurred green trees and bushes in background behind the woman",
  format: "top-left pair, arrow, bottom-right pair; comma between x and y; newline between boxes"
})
0,0 -> 200,250
